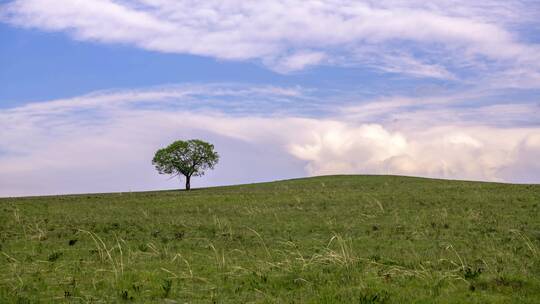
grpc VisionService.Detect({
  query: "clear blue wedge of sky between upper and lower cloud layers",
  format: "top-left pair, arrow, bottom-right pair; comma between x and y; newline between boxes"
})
0,24 -> 442,107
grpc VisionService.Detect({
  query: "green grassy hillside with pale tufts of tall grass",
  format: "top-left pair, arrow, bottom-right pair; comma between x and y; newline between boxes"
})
0,176 -> 540,303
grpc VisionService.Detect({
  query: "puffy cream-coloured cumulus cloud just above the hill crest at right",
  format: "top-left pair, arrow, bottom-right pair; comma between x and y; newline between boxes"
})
291,124 -> 540,181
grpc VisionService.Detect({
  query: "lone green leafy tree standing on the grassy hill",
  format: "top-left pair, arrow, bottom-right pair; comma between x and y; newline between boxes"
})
152,139 -> 219,190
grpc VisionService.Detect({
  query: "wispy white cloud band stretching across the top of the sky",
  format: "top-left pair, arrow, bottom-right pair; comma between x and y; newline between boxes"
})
0,0 -> 540,81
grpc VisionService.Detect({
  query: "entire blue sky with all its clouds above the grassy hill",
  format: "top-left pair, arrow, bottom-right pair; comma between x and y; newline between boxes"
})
0,0 -> 540,196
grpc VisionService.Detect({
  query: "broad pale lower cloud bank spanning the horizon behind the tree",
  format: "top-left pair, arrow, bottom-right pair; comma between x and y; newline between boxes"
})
0,85 -> 540,196
